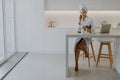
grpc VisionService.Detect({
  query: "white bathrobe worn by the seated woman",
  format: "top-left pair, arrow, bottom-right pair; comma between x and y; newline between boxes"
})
76,16 -> 94,49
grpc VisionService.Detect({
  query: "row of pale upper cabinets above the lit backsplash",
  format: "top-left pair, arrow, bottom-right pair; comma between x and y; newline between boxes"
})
45,0 -> 120,11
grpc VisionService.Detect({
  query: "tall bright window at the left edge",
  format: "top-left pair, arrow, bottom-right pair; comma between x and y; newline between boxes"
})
0,0 -> 16,63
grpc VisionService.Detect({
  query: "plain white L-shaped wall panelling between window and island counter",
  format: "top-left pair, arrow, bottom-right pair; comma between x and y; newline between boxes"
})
16,0 -> 120,54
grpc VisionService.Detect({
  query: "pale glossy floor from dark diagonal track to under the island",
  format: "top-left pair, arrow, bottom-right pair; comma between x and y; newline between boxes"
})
4,53 -> 120,80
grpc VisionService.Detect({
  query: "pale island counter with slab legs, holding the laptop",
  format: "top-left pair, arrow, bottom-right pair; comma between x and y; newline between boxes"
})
66,32 -> 120,77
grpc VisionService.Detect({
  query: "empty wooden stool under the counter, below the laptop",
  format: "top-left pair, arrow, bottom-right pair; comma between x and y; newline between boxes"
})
96,42 -> 113,68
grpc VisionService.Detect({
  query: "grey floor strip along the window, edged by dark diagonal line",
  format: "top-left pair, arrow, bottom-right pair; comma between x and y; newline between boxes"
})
0,52 -> 27,80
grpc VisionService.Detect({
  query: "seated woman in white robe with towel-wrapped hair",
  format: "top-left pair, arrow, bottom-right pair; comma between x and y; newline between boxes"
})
75,5 -> 94,71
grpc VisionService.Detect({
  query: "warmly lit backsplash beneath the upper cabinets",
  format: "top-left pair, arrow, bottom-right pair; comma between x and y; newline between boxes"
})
45,11 -> 120,27
